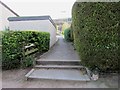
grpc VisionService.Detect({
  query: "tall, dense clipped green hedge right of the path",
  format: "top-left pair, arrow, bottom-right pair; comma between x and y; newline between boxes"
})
72,2 -> 120,71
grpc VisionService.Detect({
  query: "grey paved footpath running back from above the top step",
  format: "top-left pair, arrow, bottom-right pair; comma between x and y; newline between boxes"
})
40,36 -> 79,61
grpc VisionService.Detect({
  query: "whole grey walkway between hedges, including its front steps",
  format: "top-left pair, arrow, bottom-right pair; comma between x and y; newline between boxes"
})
26,36 -> 90,81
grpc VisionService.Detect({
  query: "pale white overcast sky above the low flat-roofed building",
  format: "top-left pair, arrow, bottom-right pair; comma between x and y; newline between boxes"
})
1,0 -> 76,19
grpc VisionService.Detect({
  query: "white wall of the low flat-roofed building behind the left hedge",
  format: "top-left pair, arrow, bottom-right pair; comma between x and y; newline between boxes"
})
10,20 -> 56,47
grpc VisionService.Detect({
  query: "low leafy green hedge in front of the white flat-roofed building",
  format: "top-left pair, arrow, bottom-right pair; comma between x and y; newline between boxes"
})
2,31 -> 50,69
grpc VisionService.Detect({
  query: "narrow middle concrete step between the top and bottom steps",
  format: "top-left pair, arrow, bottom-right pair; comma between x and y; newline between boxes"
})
35,65 -> 84,69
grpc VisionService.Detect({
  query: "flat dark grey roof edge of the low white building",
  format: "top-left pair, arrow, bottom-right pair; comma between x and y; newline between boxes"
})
8,15 -> 56,27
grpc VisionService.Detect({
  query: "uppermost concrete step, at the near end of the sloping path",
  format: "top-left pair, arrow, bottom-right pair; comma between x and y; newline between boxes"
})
36,60 -> 80,65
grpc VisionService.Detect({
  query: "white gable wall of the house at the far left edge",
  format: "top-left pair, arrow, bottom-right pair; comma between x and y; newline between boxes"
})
0,3 -> 15,31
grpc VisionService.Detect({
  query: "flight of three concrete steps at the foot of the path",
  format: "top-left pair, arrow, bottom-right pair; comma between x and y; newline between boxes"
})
25,59 -> 90,81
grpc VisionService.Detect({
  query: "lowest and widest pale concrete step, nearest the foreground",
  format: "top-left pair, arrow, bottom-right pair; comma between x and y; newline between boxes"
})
25,69 -> 90,81
